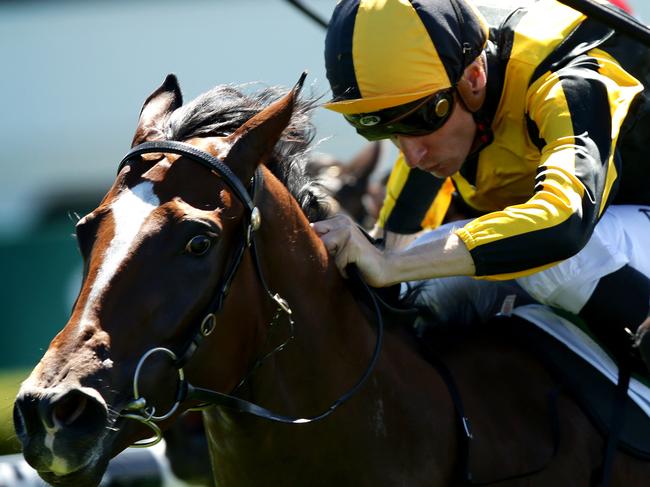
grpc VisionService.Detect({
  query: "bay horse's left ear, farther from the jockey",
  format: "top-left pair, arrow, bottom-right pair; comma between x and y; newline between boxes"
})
131,74 -> 183,147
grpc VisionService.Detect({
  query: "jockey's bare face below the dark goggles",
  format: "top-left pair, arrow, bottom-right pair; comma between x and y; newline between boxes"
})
393,93 -> 476,178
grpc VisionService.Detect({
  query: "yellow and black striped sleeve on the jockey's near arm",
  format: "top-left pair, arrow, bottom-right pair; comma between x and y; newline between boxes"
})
456,65 -> 640,279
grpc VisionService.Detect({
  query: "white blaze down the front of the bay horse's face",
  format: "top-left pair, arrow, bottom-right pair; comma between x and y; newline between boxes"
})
81,181 -> 160,323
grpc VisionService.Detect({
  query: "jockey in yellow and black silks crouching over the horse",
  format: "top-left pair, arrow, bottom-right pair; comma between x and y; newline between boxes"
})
313,0 -> 650,374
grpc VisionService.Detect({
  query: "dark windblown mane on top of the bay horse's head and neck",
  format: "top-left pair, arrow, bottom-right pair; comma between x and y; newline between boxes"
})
163,85 -> 331,221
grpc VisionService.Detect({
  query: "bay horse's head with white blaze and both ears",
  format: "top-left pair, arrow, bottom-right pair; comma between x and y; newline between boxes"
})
14,75 -> 327,485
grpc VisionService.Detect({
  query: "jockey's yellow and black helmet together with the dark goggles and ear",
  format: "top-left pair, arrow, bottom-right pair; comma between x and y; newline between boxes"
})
325,0 -> 488,145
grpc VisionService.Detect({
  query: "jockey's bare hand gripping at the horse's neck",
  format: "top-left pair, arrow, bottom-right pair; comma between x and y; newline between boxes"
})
311,215 -> 391,287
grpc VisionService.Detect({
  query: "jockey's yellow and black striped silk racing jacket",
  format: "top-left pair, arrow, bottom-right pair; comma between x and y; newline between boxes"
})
368,0 -> 650,279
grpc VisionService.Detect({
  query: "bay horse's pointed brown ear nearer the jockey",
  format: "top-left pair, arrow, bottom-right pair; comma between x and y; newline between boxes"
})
224,72 -> 307,181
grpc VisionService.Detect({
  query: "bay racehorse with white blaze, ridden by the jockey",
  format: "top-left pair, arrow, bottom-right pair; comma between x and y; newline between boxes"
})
14,75 -> 650,487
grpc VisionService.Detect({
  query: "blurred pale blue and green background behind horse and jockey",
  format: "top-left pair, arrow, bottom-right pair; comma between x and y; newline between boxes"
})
0,0 -> 650,454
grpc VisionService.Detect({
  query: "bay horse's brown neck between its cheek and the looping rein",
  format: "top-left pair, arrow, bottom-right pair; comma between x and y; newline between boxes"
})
242,173 -> 375,403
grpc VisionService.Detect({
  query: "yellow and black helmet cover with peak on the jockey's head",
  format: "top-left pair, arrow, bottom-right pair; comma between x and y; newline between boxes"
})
325,0 -> 488,114
